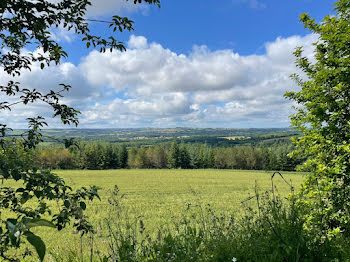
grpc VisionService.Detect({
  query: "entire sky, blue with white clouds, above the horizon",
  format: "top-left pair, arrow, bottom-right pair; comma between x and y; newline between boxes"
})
0,0 -> 335,128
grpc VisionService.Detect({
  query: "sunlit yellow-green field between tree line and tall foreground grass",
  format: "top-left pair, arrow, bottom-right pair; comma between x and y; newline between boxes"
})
2,170 -> 303,260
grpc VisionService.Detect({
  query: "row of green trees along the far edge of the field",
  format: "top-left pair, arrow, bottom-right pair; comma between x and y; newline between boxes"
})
34,141 -> 304,171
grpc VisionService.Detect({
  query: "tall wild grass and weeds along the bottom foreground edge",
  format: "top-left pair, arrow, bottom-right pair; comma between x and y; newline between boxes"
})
50,173 -> 350,262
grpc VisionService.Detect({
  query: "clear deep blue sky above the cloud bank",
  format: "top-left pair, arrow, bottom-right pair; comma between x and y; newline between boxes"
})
65,0 -> 335,63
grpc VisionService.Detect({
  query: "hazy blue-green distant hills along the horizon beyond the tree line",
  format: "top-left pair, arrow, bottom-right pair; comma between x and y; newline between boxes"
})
8,127 -> 298,146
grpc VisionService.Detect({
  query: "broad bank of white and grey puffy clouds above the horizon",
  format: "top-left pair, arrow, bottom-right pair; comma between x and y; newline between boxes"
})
2,35 -> 317,127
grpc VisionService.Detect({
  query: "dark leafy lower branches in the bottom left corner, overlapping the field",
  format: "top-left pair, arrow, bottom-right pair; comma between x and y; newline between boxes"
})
0,141 -> 98,261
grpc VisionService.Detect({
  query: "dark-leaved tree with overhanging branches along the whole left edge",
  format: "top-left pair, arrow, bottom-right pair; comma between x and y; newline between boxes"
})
0,0 -> 159,261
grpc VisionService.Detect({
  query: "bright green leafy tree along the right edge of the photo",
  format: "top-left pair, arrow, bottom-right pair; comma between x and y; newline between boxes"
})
286,0 -> 350,241
